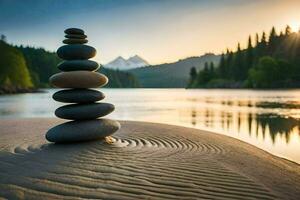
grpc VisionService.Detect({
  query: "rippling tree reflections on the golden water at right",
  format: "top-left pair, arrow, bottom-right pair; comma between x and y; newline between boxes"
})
186,99 -> 300,143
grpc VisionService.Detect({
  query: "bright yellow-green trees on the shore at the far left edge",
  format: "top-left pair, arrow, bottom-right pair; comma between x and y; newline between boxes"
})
0,40 -> 33,88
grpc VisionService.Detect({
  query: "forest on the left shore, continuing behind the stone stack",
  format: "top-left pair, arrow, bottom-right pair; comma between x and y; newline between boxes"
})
0,35 -> 139,94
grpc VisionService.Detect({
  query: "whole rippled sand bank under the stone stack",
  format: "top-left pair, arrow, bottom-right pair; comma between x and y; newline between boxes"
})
0,119 -> 300,199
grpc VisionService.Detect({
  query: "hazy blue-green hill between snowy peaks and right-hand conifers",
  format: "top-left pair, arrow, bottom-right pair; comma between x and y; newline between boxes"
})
128,53 -> 220,88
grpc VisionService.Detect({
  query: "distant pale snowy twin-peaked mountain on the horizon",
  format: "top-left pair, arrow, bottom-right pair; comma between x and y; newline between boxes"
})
104,55 -> 149,70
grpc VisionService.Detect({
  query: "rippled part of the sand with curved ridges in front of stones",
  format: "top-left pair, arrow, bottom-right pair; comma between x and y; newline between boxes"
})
0,122 -> 275,199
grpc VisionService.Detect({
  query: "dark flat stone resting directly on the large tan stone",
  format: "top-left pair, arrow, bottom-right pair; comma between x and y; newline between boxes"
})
57,60 -> 99,71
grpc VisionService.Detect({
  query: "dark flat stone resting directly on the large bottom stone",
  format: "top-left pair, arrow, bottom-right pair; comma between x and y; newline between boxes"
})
55,103 -> 115,120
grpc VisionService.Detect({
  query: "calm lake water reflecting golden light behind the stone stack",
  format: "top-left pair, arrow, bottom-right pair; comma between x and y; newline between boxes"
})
0,89 -> 300,163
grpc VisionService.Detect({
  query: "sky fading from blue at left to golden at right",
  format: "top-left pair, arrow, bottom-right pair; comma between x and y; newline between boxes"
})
0,0 -> 300,64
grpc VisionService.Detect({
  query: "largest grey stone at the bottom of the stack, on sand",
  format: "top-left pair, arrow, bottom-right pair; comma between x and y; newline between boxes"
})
46,119 -> 121,143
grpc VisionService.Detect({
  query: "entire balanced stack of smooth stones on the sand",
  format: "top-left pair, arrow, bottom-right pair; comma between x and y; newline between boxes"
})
46,28 -> 120,143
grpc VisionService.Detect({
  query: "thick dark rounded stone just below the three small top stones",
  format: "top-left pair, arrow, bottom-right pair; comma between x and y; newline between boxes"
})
56,44 -> 96,60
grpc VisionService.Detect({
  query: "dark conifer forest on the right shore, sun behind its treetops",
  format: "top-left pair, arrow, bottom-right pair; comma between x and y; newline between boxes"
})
187,26 -> 300,88
